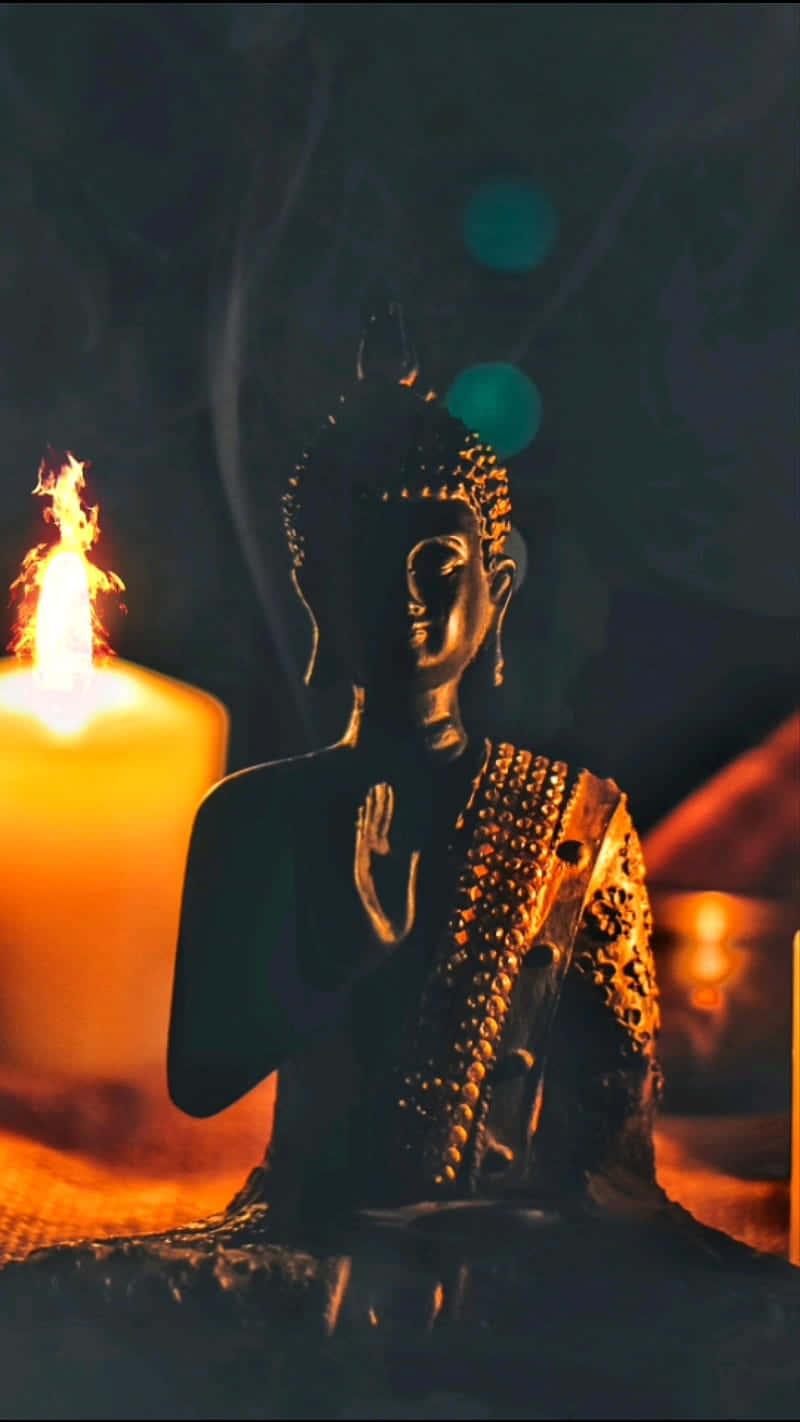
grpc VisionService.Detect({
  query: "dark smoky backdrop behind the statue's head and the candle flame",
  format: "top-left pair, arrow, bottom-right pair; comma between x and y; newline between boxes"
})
0,4 -> 800,828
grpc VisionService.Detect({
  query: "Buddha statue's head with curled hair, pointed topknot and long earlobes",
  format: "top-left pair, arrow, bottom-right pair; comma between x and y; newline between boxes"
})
284,303 -> 514,756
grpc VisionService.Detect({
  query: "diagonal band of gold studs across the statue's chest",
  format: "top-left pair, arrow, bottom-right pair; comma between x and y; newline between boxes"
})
389,742 -> 571,1190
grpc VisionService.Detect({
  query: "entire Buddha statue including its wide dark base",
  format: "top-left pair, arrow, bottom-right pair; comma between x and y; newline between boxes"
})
1,310 -> 800,1418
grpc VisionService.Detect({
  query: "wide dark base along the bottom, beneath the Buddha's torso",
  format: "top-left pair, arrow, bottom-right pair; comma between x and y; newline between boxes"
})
0,1204 -> 800,1418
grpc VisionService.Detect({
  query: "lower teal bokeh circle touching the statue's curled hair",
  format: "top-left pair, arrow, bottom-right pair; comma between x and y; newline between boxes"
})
446,361 -> 541,458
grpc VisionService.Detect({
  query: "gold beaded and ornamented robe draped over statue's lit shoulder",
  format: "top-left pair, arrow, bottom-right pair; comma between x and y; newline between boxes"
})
383,744 -> 658,1196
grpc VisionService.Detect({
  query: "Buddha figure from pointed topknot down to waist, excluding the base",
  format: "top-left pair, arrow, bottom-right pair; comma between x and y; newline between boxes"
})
169,306 -> 659,1240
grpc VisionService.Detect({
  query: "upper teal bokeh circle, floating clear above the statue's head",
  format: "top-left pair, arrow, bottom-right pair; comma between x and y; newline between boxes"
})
463,178 -> 558,273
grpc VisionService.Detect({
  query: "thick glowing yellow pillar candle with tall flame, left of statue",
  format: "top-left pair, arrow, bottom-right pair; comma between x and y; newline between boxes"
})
0,455 -> 227,1085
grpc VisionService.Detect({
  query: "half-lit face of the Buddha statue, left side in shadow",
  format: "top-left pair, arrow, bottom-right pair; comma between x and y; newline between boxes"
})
355,499 -> 513,697
